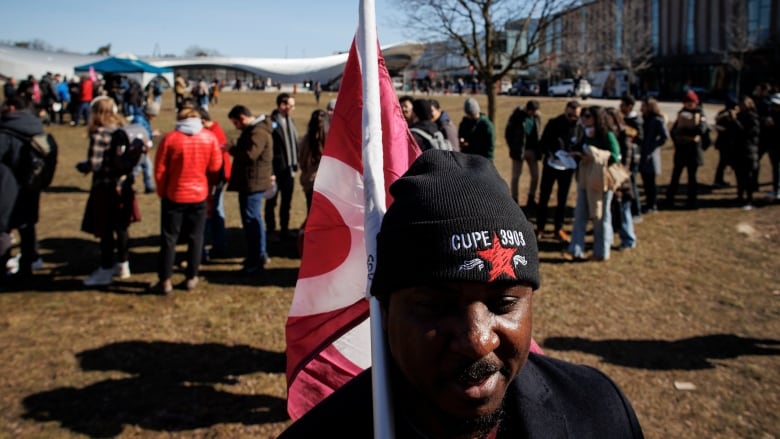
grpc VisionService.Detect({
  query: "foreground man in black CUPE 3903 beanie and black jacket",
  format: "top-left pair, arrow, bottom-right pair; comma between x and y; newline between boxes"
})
280,150 -> 642,438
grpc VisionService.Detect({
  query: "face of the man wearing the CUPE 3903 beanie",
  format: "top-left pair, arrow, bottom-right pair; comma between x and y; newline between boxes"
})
383,282 -> 533,432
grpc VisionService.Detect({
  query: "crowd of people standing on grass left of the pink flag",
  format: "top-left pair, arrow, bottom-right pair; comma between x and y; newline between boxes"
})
0,75 -> 320,294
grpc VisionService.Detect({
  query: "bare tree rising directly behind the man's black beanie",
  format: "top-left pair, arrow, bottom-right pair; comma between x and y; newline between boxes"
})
396,0 -> 573,120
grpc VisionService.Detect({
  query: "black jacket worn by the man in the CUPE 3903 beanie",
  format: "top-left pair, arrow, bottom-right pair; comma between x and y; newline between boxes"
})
279,354 -> 643,439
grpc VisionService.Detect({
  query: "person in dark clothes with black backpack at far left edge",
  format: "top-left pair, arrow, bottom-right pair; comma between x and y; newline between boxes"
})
0,97 -> 48,279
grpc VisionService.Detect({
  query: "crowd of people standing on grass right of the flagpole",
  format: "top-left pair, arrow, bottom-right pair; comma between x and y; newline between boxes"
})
399,84 -> 780,261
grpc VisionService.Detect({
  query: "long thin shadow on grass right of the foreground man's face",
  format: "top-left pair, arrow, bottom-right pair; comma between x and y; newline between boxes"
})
542,334 -> 780,370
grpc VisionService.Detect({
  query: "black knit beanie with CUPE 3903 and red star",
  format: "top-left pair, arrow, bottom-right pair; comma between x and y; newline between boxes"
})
371,150 -> 539,299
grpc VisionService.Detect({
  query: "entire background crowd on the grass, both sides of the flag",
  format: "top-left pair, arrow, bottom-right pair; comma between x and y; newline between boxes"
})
0,75 -> 780,288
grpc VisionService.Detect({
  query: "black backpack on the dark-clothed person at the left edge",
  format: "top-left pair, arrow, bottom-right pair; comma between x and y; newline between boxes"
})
2,130 -> 59,191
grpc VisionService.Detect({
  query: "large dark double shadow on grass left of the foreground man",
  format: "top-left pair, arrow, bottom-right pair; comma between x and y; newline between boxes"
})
23,341 -> 288,437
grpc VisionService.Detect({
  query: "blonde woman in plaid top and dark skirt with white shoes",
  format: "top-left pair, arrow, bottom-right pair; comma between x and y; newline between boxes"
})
76,96 -> 141,287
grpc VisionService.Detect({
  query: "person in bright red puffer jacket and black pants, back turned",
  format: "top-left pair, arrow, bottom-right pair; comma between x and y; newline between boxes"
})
150,108 -> 222,294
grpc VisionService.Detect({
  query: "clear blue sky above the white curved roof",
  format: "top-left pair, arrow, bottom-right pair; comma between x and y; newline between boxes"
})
0,0 -> 408,58
